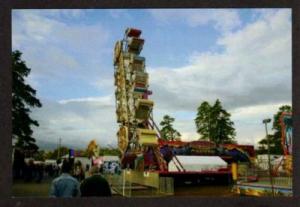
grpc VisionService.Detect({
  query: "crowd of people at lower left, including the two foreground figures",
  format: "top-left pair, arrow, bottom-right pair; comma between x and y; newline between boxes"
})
13,151 -> 112,197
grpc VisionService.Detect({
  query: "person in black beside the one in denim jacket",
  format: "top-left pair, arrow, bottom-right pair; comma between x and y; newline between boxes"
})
80,166 -> 111,197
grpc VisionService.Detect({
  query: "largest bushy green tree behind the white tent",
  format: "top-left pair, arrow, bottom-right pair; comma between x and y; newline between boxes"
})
195,99 -> 236,145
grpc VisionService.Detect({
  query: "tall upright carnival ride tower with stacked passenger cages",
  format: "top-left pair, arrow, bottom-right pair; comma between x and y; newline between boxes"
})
113,28 -> 167,171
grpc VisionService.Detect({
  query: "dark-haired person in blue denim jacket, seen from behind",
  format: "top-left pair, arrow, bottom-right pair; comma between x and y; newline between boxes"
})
50,160 -> 80,197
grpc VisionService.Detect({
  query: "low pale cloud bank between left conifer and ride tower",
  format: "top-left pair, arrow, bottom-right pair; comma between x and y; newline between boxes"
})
33,97 -> 117,149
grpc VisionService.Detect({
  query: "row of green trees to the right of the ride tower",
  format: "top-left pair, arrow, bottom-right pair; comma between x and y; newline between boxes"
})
160,102 -> 292,155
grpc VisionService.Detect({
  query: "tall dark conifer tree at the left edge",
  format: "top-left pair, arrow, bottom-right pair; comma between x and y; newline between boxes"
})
12,50 -> 42,152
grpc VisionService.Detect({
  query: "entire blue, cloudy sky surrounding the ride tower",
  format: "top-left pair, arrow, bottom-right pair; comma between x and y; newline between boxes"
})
12,9 -> 292,149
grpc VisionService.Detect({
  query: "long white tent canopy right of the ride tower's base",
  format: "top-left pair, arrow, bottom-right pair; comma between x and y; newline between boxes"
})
169,156 -> 227,172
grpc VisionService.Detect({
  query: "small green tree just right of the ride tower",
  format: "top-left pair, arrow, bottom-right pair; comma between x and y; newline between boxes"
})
160,115 -> 181,141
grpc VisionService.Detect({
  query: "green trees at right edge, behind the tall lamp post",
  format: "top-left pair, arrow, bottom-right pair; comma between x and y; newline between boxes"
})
257,105 -> 292,155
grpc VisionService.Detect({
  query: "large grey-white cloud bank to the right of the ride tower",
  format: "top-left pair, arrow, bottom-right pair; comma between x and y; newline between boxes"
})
148,10 -> 292,144
